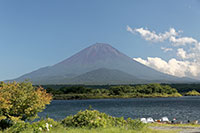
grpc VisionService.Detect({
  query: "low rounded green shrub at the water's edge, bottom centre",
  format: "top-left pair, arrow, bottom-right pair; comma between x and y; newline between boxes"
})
62,110 -> 145,129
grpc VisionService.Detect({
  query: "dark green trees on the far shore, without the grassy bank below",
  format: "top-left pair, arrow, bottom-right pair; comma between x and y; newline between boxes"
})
47,83 -> 178,95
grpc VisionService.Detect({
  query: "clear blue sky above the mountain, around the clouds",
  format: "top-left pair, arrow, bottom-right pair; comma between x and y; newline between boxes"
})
0,0 -> 200,80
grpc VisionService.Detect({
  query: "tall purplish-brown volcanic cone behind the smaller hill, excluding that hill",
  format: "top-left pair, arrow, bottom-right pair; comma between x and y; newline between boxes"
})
13,43 -> 196,84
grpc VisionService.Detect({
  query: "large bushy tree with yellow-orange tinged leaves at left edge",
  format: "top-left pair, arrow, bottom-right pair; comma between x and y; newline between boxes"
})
0,82 -> 52,121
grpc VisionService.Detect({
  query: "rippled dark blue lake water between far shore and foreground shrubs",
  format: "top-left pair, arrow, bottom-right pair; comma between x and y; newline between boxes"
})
39,97 -> 200,121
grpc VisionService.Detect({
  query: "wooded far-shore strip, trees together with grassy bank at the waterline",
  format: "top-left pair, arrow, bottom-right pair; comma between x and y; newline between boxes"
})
47,83 -> 181,100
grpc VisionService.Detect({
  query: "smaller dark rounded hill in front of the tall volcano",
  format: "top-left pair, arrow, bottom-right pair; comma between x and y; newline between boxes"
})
67,68 -> 145,85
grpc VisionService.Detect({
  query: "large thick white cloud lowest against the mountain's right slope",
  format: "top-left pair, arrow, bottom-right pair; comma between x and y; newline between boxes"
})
133,57 -> 200,77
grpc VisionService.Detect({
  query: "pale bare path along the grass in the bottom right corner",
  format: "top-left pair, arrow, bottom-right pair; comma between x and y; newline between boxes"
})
149,126 -> 200,133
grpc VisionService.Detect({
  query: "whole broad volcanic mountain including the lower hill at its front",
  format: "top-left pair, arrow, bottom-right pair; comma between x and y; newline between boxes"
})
15,43 -> 197,84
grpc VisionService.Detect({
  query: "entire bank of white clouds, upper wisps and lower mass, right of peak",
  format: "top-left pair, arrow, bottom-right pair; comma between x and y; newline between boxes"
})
127,26 -> 200,78
